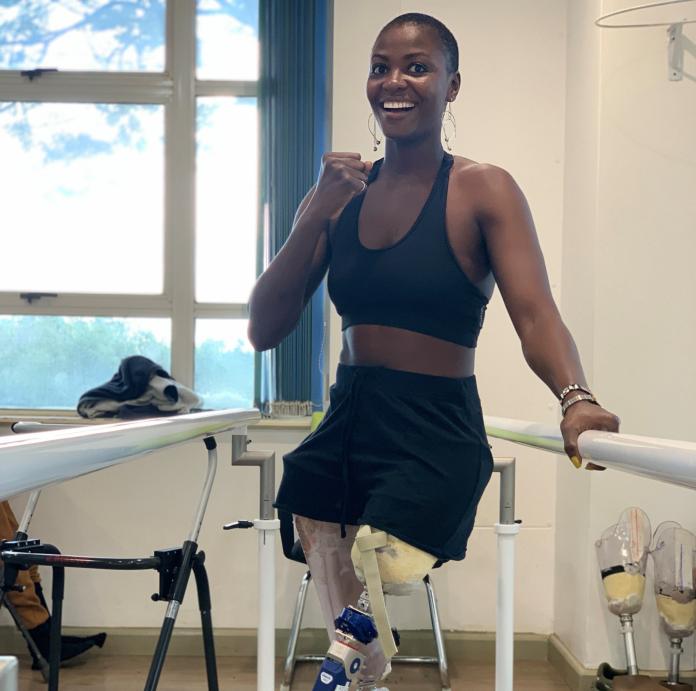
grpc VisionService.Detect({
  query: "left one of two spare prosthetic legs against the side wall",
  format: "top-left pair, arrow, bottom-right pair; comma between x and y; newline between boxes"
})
595,507 -> 650,689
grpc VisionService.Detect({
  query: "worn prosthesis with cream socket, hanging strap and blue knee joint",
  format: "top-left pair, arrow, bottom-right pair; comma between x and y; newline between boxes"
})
313,525 -> 437,691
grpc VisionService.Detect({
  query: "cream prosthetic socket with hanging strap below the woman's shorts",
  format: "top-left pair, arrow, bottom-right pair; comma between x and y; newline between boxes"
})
351,525 -> 437,660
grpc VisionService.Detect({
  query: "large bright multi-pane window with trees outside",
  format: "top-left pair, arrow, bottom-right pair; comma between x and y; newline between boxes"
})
0,0 -> 259,408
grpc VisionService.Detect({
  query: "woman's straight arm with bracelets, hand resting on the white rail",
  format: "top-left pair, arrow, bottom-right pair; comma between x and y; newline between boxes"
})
477,166 -> 619,465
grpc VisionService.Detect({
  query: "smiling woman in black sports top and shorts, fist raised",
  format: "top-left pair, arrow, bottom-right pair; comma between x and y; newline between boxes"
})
249,13 -> 618,688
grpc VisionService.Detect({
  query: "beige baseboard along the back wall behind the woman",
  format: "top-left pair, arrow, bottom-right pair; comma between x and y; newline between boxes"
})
0,626 -> 548,662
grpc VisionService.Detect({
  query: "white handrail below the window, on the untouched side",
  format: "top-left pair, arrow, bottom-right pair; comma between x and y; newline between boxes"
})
0,410 -> 261,500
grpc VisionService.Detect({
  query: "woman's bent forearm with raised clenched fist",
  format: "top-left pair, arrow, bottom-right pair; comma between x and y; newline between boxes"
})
249,153 -> 371,350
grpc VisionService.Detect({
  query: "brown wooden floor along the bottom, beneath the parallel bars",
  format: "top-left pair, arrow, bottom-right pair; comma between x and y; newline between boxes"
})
14,652 -> 568,691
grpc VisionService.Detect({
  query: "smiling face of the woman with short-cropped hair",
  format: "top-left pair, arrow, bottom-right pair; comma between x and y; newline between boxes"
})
367,24 -> 460,147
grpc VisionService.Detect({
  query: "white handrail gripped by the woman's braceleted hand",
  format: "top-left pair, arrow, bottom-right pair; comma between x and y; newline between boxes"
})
485,416 -> 696,489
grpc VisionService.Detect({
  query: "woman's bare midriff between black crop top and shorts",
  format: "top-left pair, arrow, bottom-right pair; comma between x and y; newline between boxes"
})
340,324 -> 476,379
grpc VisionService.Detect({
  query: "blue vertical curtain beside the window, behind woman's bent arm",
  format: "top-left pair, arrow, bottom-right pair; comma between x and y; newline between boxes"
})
256,0 -> 332,416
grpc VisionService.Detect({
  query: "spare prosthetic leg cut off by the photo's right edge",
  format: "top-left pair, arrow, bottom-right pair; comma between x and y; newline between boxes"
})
650,521 -> 696,691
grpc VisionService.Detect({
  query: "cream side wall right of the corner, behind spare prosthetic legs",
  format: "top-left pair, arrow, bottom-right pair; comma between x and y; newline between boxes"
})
555,0 -> 696,669
